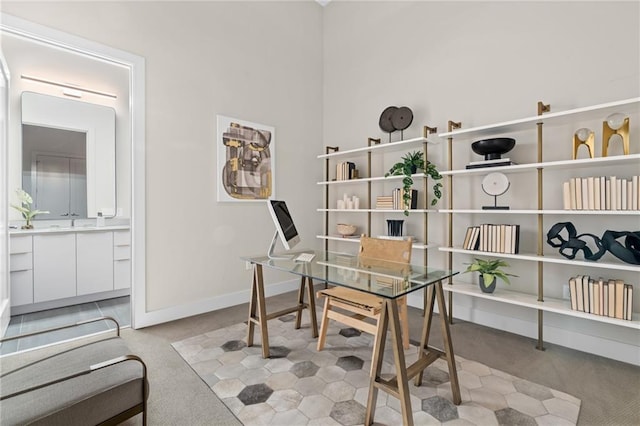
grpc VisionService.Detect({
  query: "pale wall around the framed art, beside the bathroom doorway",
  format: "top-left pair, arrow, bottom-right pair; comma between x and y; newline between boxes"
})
2,2 -> 322,319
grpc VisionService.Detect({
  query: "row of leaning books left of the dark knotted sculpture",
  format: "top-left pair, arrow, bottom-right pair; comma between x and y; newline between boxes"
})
462,223 -> 520,254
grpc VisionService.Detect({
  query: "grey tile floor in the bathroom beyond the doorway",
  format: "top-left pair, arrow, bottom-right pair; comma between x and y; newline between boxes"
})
0,296 -> 131,355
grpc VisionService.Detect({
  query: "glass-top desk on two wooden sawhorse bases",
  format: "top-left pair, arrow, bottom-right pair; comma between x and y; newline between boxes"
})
242,251 -> 461,425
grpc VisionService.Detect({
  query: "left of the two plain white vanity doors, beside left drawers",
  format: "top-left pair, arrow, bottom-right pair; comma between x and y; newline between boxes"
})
33,233 -> 76,303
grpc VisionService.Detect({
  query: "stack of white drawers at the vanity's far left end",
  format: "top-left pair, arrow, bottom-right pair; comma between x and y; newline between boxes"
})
9,235 -> 33,306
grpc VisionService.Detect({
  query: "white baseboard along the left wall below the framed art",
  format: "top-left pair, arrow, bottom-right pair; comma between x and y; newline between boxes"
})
135,279 -> 300,328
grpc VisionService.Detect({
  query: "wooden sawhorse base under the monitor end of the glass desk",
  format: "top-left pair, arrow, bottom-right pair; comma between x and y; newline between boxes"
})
247,263 -> 318,358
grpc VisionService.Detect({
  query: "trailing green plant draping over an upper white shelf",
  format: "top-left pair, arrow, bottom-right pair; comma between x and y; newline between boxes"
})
384,151 -> 442,216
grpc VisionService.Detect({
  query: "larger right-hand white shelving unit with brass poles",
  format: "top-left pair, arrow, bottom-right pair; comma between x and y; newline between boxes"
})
438,98 -> 640,349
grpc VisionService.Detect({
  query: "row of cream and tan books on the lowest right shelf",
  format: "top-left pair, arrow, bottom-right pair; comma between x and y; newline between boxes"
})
569,275 -> 633,320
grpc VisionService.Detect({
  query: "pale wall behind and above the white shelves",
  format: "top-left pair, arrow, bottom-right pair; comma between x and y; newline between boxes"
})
323,1 -> 640,364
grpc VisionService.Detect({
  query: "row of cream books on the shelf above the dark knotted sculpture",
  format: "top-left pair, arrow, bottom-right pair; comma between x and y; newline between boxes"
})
562,176 -> 640,210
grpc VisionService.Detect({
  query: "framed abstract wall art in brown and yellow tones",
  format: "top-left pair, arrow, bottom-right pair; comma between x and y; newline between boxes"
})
216,115 -> 275,202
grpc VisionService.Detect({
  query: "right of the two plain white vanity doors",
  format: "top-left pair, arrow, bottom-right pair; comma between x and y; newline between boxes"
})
76,232 -> 113,296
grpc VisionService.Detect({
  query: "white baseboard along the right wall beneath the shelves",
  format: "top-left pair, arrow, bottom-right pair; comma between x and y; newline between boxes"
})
407,292 -> 640,366
